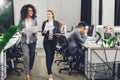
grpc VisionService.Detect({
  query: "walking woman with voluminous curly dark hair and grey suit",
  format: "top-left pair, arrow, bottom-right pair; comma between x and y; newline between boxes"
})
19,4 -> 37,80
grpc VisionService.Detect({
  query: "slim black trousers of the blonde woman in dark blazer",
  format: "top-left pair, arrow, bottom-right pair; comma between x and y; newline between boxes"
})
43,38 -> 57,74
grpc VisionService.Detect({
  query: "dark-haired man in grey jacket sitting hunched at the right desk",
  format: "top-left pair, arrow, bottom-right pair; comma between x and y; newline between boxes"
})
68,23 -> 87,71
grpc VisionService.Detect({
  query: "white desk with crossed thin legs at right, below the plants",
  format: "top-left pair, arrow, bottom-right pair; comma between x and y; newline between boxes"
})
83,42 -> 120,80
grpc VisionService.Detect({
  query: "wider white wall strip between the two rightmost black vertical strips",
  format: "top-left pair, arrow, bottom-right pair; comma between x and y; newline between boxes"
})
102,0 -> 115,26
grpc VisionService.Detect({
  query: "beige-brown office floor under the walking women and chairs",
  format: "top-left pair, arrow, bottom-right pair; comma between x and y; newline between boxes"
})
6,49 -> 86,80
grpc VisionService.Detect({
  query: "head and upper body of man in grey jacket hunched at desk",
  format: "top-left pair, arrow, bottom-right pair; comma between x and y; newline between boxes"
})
68,23 -> 87,54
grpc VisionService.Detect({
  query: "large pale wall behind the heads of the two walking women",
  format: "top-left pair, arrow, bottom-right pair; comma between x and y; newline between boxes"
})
13,0 -> 81,30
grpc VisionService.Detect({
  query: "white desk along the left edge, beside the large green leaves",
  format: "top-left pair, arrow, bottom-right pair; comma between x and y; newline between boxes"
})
0,34 -> 21,80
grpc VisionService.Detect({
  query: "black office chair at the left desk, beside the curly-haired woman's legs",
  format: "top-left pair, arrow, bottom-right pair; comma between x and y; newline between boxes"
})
6,44 -> 23,76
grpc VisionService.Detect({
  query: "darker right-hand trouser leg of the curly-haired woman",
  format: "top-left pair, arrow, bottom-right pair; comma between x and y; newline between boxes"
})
29,42 -> 36,70
